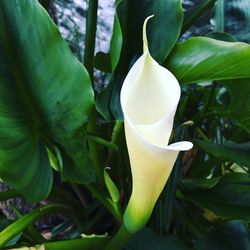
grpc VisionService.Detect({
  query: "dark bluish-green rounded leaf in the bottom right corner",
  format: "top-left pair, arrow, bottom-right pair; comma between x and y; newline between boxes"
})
195,221 -> 250,250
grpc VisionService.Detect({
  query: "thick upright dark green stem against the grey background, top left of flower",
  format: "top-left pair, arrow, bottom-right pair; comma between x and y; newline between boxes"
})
84,0 -> 98,83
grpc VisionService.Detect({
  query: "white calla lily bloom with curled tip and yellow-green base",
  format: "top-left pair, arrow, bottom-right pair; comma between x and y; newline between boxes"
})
121,17 -> 192,233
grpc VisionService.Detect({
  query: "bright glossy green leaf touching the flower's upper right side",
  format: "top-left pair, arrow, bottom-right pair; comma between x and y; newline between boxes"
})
164,37 -> 250,83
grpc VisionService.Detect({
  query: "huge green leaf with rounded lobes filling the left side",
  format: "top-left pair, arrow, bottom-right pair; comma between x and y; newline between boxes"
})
0,0 -> 93,201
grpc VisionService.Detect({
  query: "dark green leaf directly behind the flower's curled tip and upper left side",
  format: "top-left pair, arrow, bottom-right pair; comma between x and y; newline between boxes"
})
97,0 -> 183,120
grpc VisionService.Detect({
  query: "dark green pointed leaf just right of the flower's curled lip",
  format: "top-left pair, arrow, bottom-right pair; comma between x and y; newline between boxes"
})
197,140 -> 250,168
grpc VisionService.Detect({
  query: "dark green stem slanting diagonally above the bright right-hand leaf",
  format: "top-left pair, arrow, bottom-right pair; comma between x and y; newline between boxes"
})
181,0 -> 217,34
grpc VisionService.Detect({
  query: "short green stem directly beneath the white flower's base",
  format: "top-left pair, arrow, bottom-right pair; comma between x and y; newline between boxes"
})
105,225 -> 132,250
